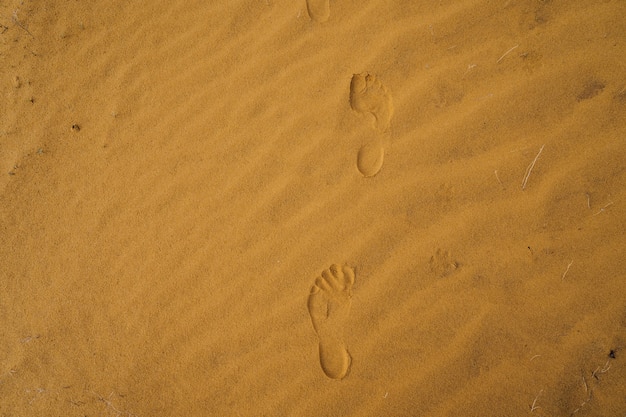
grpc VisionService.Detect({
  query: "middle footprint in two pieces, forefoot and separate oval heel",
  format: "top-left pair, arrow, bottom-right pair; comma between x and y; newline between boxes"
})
350,73 -> 393,177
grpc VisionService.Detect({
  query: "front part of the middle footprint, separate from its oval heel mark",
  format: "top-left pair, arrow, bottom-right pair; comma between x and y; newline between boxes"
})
350,73 -> 393,132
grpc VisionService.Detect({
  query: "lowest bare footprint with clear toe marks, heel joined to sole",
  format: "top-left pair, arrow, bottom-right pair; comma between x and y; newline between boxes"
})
308,265 -> 354,379
